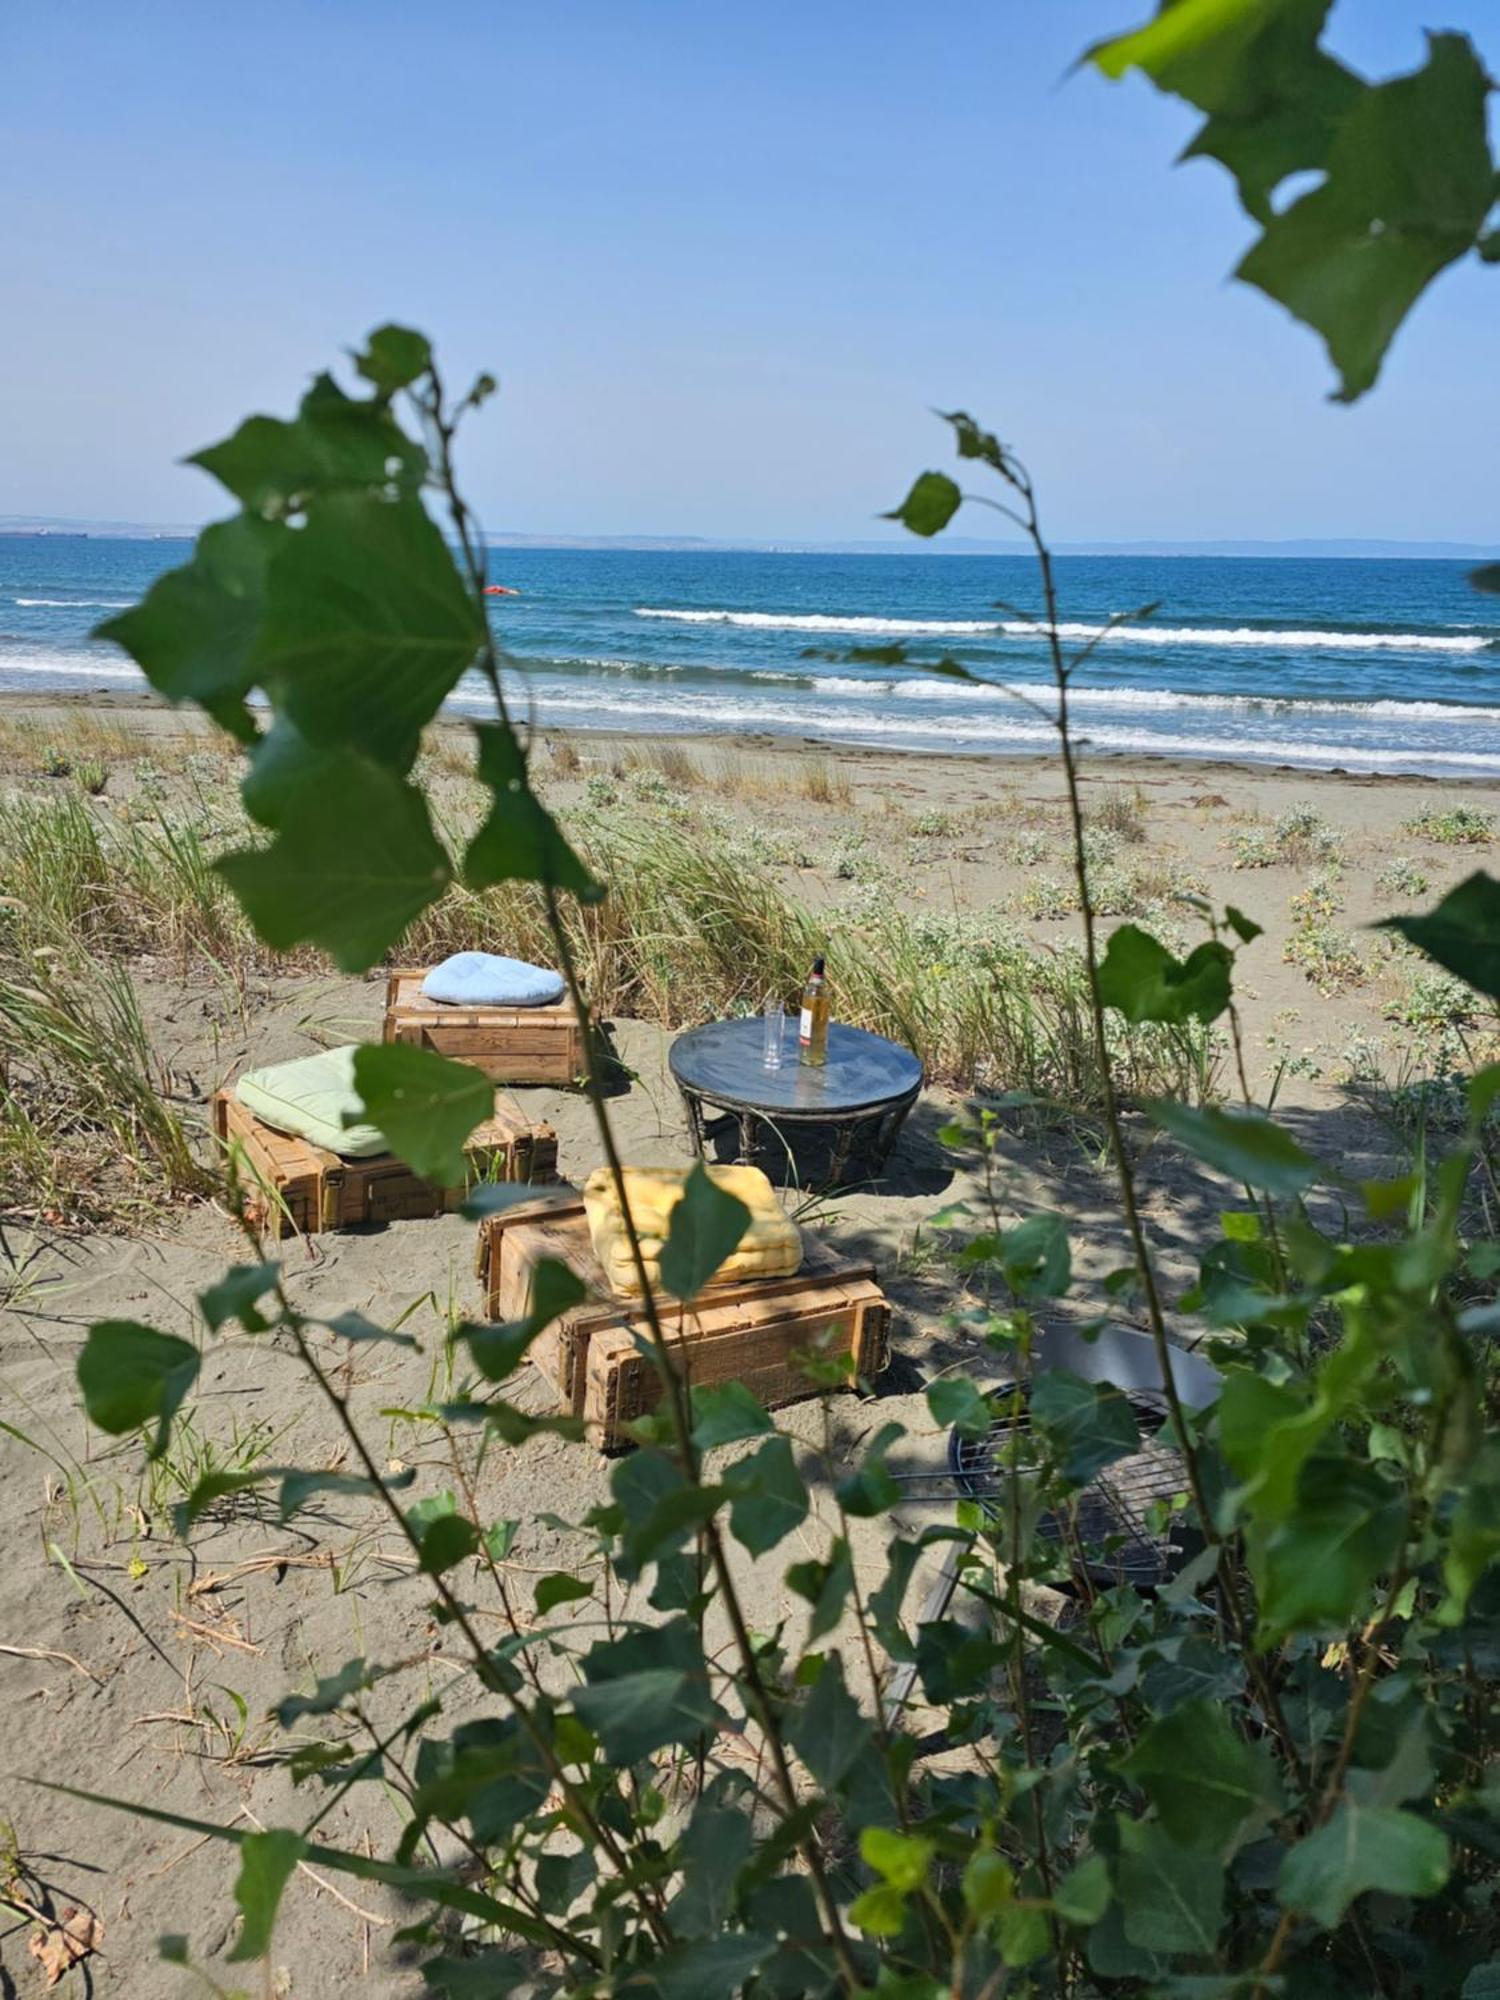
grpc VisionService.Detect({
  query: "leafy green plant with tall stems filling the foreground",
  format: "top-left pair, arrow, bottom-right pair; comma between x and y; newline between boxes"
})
61,328 -> 1500,2000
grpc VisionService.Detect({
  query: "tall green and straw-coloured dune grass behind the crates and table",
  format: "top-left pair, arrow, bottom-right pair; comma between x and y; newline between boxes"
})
0,718 -> 1216,1222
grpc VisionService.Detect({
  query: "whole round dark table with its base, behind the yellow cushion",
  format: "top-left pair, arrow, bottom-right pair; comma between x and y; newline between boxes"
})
668,1014 -> 922,1180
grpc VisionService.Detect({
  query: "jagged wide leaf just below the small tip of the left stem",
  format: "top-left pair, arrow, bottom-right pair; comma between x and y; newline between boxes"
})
188,376 -> 426,518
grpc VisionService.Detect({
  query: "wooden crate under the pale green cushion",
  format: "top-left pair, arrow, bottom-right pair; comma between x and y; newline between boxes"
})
214,1090 -> 558,1236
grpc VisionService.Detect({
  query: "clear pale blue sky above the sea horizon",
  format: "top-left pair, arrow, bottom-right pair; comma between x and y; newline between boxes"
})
0,0 -> 1500,540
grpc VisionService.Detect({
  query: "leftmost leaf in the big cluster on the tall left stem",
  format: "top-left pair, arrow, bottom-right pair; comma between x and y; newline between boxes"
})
96,516 -> 286,742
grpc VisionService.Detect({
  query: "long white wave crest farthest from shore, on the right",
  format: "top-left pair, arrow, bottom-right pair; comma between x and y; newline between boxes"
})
636,604 -> 1494,652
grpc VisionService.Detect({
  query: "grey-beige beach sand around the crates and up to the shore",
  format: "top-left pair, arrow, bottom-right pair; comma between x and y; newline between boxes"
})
0,698 -> 1500,1996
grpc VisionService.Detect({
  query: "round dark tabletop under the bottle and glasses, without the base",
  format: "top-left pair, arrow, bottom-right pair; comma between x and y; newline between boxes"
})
670,1014 -> 922,1118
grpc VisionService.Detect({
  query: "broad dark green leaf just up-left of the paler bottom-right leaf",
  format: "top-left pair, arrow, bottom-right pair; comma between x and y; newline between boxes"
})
1120,1702 -> 1282,1854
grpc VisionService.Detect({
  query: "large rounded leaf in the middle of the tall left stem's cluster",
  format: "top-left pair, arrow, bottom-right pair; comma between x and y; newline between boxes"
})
250,492 -> 484,768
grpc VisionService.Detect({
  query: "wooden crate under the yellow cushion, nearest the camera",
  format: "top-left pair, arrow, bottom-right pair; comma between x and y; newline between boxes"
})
478,1186 -> 890,1450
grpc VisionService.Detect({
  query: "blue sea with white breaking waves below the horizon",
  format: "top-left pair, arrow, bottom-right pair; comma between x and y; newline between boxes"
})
0,534 -> 1500,778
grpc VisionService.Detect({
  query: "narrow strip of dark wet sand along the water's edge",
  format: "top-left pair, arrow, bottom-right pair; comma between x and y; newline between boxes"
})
0,686 -> 1500,794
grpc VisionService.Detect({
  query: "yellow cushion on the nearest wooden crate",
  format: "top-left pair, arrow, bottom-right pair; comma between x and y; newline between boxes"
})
584,1166 -> 802,1298
